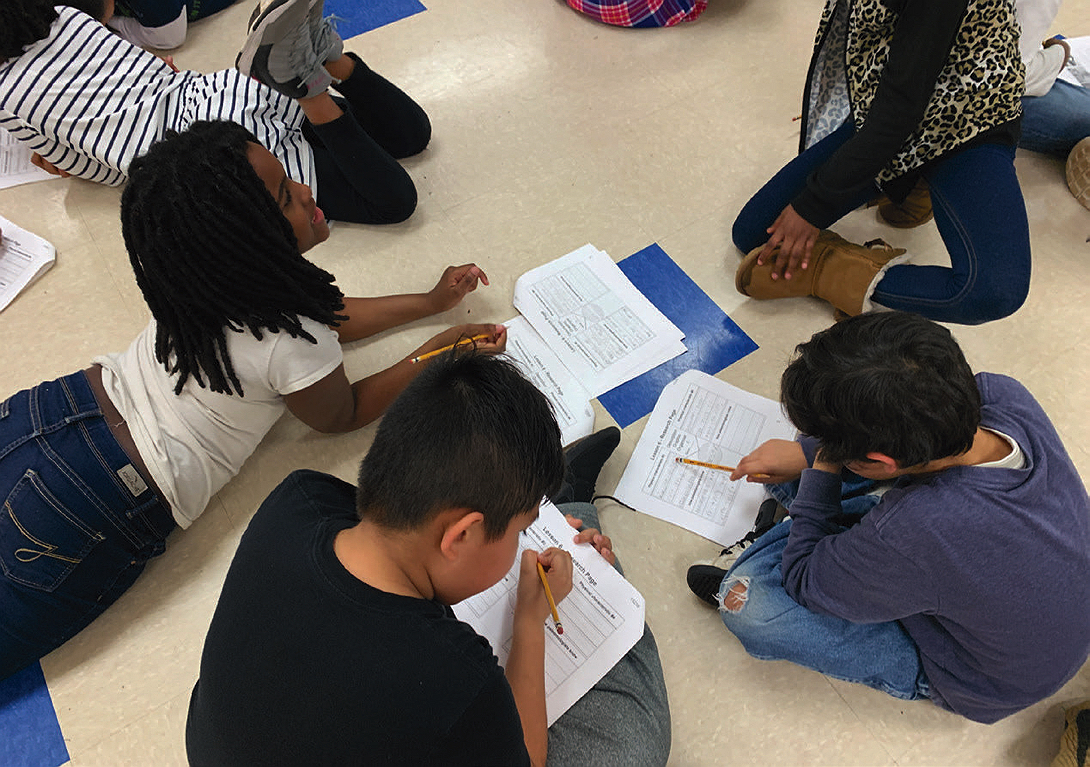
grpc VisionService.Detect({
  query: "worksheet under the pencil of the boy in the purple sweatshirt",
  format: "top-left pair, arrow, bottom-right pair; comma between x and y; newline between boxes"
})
614,370 -> 796,546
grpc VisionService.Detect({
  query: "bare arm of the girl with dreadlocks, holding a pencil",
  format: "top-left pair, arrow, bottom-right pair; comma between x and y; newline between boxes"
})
283,325 -> 507,434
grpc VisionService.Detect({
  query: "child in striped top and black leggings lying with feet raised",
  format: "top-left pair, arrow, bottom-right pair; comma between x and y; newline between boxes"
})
0,0 -> 432,223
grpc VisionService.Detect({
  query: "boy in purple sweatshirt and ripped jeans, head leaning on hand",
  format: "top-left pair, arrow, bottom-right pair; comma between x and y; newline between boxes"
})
688,312 -> 1090,723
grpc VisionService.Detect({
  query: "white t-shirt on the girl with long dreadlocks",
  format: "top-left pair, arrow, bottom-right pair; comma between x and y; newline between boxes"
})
95,317 -> 343,528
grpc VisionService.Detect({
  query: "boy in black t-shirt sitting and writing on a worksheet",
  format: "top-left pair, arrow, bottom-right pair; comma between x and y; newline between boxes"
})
186,355 -> 669,765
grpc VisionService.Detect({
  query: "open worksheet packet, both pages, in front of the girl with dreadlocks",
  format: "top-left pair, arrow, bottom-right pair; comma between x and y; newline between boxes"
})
506,239 -> 686,445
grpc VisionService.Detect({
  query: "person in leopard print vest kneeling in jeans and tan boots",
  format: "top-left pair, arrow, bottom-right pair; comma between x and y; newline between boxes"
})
732,0 -> 1030,325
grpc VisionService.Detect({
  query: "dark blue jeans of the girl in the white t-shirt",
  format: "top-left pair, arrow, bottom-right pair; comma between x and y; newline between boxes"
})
0,372 -> 174,679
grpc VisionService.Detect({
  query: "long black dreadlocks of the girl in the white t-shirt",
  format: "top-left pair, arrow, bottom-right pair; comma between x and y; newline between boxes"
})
121,121 -> 346,395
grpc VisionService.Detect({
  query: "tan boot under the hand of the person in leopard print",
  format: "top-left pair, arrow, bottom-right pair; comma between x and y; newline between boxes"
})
735,230 -> 908,316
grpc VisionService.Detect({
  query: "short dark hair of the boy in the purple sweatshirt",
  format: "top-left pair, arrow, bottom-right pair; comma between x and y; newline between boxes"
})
780,312 -> 980,467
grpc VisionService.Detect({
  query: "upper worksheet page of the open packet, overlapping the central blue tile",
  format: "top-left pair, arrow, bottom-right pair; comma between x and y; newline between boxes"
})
514,245 -> 686,397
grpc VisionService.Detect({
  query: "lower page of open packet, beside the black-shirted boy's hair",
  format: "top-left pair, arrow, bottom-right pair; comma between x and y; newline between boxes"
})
504,316 -> 594,445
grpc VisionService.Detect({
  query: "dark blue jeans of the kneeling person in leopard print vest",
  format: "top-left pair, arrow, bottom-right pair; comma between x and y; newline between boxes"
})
732,122 -> 1030,325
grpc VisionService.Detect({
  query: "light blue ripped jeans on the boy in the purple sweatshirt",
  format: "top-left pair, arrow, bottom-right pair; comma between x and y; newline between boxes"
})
719,475 -> 930,701
